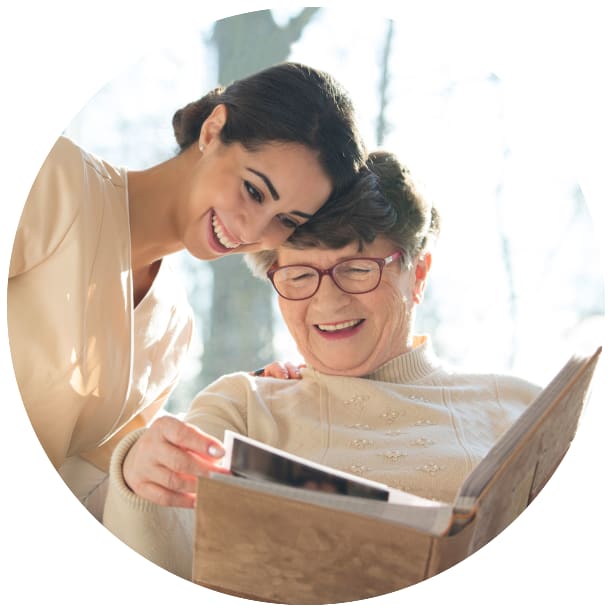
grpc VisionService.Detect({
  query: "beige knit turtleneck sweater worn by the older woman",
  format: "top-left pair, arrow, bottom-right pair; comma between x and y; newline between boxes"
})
104,337 -> 540,578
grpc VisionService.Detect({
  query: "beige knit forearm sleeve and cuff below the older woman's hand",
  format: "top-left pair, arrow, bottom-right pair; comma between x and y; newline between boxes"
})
102,429 -> 195,580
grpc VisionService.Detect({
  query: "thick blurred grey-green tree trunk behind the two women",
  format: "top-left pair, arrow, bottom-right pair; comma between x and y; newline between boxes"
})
197,8 -> 318,387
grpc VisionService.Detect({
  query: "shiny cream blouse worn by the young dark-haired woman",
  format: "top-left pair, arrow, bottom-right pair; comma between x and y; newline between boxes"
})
8,137 -> 192,470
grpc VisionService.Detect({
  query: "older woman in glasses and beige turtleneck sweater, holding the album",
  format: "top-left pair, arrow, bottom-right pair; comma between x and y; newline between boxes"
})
105,152 -> 539,577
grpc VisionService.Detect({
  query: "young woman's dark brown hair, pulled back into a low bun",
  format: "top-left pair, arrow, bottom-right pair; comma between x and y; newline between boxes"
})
172,62 -> 365,194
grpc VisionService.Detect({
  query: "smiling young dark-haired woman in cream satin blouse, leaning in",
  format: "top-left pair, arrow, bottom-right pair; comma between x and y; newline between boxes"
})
8,63 -> 364,518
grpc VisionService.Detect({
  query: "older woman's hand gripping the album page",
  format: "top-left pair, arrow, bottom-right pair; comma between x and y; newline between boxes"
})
123,416 -> 227,508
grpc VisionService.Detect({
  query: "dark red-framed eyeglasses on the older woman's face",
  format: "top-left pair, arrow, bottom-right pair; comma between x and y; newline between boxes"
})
268,251 -> 403,300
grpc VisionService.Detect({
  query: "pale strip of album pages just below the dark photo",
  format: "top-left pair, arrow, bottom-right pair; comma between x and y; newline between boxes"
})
209,472 -> 453,535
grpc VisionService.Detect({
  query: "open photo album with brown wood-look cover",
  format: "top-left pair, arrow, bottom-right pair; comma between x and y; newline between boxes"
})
193,347 -> 601,604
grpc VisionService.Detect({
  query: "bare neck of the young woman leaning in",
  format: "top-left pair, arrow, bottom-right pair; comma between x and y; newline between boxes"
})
128,146 -> 195,271
